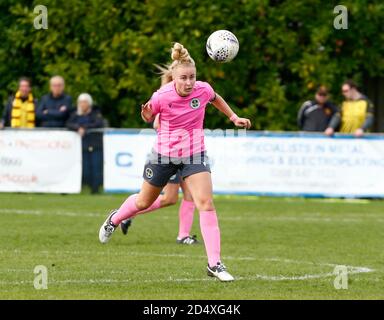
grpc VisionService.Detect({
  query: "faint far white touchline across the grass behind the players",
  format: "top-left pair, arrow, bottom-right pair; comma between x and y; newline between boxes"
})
0,209 -> 384,223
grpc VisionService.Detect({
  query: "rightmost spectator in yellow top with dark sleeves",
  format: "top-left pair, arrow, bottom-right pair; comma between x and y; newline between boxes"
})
340,80 -> 374,137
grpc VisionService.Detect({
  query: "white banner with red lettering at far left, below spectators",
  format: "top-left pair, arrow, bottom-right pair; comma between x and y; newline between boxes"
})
0,130 -> 82,193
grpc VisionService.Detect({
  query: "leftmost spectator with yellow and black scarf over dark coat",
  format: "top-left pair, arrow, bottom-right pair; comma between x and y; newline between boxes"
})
0,78 -> 37,129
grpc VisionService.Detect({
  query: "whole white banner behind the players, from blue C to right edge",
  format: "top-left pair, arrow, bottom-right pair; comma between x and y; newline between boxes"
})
104,132 -> 384,197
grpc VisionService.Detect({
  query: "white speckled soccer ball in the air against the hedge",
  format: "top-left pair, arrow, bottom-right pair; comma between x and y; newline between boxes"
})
206,30 -> 239,62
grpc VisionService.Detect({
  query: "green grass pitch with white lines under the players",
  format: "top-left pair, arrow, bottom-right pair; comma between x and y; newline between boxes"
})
0,193 -> 384,299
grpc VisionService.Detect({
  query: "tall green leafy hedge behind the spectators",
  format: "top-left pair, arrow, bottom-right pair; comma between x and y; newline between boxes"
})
0,0 -> 384,130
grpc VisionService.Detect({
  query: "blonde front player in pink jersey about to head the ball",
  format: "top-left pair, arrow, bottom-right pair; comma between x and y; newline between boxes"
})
99,43 -> 251,281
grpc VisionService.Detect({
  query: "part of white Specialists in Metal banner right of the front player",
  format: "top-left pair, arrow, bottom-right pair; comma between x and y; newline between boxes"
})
207,135 -> 384,197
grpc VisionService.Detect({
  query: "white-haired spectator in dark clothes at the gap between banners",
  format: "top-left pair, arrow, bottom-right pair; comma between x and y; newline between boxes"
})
67,93 -> 104,193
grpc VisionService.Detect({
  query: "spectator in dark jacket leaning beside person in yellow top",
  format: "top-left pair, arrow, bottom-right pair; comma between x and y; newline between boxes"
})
297,86 -> 340,136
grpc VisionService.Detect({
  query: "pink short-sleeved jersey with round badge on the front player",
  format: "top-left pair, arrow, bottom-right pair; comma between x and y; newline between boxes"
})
151,81 -> 215,158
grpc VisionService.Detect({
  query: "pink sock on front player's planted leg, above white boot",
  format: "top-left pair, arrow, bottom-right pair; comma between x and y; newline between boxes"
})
200,210 -> 220,267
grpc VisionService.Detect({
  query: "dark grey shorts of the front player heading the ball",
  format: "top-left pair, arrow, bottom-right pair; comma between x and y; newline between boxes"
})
143,151 -> 211,187
